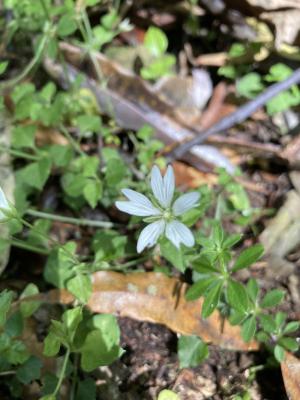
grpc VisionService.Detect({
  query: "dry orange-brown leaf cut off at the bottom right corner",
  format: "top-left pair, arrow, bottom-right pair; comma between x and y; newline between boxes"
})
281,353 -> 300,400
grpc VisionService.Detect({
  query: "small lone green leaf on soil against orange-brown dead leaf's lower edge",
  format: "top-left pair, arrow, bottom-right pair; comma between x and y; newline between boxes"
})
178,335 -> 208,368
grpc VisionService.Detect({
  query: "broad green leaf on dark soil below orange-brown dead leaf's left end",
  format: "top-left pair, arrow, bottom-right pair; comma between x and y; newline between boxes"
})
80,330 -> 123,372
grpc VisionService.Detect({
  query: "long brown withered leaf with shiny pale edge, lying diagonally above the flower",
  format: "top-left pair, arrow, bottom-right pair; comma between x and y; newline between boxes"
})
44,42 -> 234,173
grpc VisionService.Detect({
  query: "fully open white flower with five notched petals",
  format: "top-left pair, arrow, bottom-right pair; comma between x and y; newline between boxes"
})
116,165 -> 200,253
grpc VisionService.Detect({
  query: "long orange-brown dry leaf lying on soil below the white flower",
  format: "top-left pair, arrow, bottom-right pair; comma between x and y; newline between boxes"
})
46,271 -> 258,351
